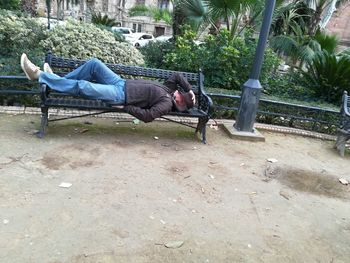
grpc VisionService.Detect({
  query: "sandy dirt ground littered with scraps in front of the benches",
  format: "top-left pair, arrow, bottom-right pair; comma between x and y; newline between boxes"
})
0,114 -> 350,263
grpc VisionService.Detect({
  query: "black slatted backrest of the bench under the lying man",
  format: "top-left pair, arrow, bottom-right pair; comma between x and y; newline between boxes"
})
45,53 -> 204,94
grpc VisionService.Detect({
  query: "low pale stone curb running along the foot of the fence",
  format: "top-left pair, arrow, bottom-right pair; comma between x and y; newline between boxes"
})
0,106 -> 336,141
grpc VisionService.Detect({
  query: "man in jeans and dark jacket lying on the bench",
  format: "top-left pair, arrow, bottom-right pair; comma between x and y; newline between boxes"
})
21,54 -> 195,122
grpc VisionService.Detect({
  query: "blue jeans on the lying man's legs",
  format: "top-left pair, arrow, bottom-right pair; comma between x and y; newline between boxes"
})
39,58 -> 125,104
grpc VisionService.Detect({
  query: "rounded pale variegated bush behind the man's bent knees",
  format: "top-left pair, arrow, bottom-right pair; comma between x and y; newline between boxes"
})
41,21 -> 144,65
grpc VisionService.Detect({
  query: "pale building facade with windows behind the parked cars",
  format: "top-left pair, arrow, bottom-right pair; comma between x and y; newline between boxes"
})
38,0 -> 172,36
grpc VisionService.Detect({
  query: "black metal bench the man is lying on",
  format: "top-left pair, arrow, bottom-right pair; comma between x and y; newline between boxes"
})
38,53 -> 213,143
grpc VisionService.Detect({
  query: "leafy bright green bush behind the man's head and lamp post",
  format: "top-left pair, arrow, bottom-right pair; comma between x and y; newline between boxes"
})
142,29 -> 279,90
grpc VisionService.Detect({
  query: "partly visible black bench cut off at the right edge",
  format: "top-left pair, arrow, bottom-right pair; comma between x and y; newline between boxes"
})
335,91 -> 350,156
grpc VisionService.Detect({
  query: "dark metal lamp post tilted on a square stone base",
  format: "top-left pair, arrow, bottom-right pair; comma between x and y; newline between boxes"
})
234,0 -> 276,132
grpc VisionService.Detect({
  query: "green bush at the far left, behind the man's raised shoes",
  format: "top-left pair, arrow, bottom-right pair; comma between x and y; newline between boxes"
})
0,10 -> 41,105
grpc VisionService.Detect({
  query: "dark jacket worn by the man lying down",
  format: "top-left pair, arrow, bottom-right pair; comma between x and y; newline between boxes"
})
124,73 -> 191,122
